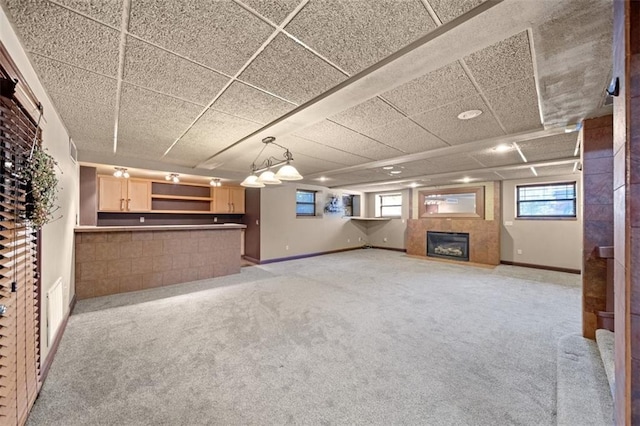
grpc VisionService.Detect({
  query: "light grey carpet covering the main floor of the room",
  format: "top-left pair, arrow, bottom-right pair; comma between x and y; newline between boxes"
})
28,249 -> 580,426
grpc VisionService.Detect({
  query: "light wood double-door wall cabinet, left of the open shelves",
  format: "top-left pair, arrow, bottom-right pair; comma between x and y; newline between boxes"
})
98,176 -> 151,212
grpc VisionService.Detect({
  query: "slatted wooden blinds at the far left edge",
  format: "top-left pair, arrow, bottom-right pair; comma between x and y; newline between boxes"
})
0,91 -> 40,425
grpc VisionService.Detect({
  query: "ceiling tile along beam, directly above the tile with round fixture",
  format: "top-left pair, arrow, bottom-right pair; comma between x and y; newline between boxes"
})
382,62 -> 478,115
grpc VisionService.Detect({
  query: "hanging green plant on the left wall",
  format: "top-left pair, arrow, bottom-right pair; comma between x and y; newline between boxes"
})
23,145 -> 58,229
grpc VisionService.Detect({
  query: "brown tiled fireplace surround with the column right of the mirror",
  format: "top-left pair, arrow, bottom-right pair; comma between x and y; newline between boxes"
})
407,182 -> 501,265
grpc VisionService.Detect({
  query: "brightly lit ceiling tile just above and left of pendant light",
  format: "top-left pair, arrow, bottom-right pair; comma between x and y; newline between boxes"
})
167,110 -> 261,169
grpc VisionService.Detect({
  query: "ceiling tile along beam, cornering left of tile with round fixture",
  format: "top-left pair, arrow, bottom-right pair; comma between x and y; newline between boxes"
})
329,98 -> 404,133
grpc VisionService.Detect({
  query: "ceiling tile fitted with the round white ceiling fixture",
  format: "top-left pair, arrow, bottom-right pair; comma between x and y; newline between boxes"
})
412,96 -> 504,145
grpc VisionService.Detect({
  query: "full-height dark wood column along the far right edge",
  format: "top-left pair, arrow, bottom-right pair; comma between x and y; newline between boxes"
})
613,0 -> 640,425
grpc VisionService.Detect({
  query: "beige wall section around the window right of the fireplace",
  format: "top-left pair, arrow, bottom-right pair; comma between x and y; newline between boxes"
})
500,174 -> 582,270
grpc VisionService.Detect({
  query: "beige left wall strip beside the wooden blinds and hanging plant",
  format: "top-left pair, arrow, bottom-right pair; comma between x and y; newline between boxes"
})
0,8 -> 78,360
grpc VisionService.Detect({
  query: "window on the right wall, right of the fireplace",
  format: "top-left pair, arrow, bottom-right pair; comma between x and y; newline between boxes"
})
516,182 -> 576,219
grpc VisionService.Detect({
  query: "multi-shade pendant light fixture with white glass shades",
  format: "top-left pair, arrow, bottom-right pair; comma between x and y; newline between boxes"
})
240,136 -> 303,188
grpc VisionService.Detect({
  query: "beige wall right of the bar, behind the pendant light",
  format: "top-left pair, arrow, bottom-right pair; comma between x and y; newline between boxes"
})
260,183 -> 367,261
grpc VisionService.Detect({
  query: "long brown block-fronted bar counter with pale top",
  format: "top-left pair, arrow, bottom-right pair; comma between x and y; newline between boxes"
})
75,223 -> 246,299
